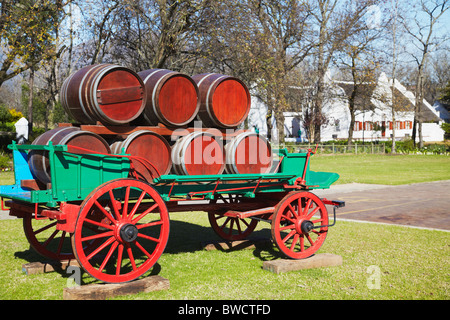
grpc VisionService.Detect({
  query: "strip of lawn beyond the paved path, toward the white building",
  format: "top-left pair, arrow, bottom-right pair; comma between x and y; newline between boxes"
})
310,154 -> 450,185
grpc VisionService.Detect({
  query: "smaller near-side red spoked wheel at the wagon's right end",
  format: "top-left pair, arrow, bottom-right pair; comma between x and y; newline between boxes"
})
272,191 -> 328,259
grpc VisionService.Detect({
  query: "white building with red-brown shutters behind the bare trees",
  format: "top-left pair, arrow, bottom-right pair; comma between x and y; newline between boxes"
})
248,73 -> 444,141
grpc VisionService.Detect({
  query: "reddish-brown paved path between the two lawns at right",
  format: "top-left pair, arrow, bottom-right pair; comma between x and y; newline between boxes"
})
315,180 -> 450,230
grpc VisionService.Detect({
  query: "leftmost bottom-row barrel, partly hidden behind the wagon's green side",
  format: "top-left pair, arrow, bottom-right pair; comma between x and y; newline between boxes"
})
28,127 -> 111,184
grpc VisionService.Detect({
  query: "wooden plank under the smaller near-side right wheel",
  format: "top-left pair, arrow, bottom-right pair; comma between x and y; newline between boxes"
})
263,253 -> 342,274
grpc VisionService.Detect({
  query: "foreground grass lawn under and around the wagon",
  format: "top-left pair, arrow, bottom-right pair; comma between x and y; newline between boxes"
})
0,212 -> 450,300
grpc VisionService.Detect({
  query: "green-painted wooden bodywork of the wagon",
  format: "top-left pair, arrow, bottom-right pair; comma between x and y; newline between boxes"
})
0,143 -> 339,206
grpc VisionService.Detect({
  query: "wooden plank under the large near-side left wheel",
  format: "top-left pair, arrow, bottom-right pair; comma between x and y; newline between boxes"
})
63,276 -> 169,300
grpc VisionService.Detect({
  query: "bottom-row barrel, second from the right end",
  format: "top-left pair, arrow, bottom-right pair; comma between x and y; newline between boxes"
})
172,131 -> 225,175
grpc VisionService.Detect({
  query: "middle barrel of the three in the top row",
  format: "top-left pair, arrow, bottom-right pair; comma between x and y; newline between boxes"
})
138,69 -> 200,127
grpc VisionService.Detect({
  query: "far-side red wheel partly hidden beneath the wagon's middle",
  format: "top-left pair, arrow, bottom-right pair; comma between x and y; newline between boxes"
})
208,194 -> 258,241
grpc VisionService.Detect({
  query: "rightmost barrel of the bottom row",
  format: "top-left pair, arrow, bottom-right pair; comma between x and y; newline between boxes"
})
224,132 -> 273,174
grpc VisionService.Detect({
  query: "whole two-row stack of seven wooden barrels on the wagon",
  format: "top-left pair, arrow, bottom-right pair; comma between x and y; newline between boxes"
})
28,64 -> 272,183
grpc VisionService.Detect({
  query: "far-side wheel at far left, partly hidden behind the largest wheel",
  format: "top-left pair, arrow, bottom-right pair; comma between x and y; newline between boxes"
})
23,213 -> 75,261
